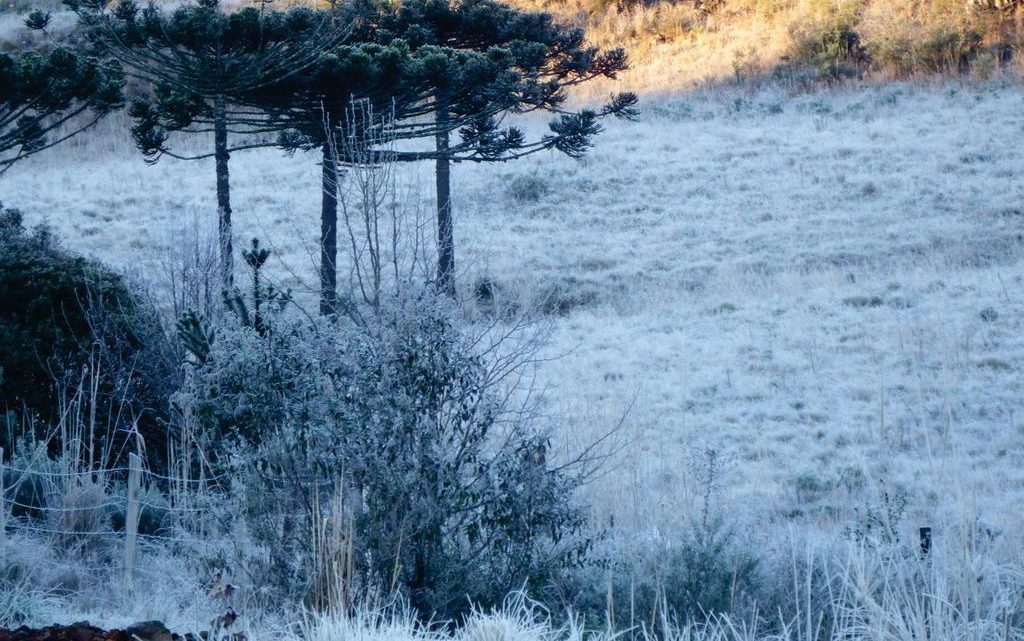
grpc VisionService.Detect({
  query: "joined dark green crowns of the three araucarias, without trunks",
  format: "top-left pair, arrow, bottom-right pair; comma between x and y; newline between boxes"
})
94,0 -> 636,163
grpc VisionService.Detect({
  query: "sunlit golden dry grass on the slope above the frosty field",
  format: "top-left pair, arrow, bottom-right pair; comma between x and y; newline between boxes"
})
511,0 -> 1024,94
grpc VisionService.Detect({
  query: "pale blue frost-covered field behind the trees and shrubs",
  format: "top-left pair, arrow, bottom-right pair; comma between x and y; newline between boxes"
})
8,77 -> 1024,536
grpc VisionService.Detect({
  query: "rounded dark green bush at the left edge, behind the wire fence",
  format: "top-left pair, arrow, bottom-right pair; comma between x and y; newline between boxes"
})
0,206 -> 177,463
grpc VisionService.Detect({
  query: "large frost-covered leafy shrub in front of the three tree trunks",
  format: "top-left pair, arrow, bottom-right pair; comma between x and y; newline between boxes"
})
177,295 -> 586,618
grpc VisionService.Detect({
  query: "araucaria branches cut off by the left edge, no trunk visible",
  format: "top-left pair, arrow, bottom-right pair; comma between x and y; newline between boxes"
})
0,33 -> 123,173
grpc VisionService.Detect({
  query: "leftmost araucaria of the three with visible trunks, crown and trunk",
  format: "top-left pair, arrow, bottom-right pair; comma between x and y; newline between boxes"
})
66,0 -> 343,289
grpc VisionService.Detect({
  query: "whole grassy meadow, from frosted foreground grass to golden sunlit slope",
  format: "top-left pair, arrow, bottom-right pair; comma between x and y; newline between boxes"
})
0,0 -> 1024,641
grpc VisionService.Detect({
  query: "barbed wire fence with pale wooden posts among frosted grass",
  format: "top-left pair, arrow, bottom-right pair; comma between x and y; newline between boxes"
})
0,438 -> 348,605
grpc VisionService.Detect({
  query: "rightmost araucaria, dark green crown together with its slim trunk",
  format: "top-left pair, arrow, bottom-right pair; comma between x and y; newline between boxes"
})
360,0 -> 637,296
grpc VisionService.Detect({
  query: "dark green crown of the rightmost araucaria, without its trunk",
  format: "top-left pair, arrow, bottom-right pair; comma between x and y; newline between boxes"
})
355,0 -> 637,161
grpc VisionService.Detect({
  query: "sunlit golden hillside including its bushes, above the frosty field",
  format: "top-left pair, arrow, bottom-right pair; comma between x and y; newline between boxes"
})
512,0 -> 1024,93
